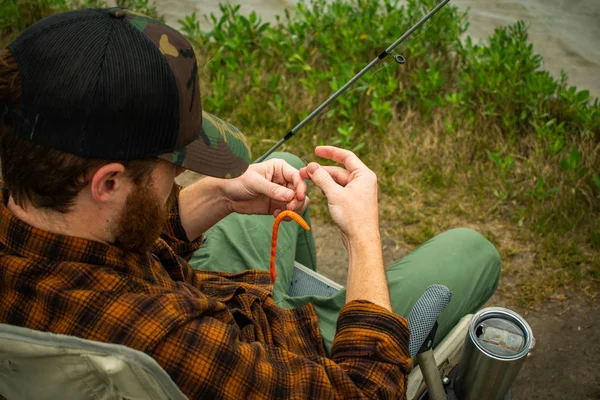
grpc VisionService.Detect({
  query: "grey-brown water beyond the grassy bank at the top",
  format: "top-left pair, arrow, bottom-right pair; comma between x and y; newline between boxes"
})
156,0 -> 600,96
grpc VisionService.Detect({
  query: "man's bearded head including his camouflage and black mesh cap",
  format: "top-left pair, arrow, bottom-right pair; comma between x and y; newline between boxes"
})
0,9 -> 249,253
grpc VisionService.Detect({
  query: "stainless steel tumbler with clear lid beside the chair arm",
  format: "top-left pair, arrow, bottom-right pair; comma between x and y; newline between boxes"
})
455,307 -> 535,400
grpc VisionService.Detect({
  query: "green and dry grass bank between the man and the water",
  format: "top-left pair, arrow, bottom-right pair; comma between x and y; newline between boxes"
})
0,0 -> 600,304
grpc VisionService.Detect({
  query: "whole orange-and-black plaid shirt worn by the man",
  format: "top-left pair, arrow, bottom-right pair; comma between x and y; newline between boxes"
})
0,189 -> 411,399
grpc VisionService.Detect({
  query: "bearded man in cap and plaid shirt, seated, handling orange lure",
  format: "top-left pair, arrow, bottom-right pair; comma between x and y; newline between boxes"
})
0,8 -> 500,399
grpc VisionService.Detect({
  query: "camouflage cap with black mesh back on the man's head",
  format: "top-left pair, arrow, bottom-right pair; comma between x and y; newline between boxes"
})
8,8 -> 250,178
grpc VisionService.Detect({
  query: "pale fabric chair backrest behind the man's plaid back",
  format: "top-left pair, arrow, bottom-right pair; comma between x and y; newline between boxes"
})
0,324 -> 186,400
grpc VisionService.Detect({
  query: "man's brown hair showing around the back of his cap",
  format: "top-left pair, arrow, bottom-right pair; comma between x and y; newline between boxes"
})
0,49 -> 156,213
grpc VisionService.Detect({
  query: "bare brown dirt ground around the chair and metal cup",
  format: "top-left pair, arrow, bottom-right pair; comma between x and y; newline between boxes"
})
312,218 -> 600,399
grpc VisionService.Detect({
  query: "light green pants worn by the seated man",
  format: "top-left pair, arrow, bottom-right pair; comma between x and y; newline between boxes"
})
190,153 -> 500,350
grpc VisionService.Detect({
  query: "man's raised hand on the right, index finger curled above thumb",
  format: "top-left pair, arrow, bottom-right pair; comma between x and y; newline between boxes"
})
300,146 -> 379,242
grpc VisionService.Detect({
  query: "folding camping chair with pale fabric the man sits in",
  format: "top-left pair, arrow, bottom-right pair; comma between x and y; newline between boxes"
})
0,264 -> 470,400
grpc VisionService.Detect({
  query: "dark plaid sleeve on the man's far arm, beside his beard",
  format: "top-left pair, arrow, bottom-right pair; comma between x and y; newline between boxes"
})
160,184 -> 202,260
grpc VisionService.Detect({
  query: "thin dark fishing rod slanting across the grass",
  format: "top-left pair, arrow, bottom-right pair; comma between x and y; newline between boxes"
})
256,0 -> 450,163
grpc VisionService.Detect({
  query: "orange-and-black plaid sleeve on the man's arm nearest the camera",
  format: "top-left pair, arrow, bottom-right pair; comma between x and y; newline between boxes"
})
150,301 -> 411,399
